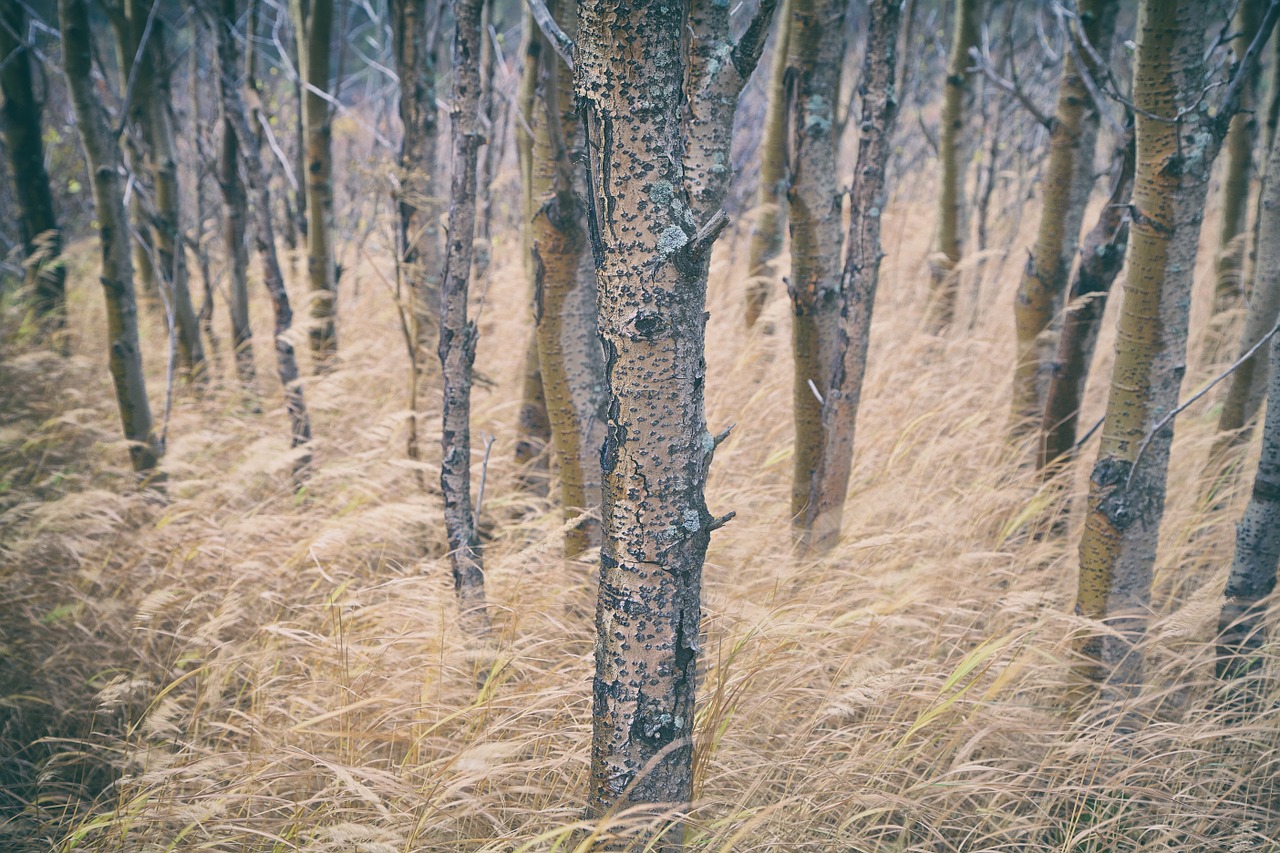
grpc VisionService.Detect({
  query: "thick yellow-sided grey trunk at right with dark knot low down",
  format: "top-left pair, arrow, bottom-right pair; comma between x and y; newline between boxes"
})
1076,0 -> 1274,697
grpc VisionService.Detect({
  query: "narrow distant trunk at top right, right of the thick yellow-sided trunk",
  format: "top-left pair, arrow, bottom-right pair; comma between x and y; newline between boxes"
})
1213,0 -> 1266,317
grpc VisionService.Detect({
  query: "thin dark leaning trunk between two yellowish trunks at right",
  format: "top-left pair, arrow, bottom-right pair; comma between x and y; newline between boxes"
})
1037,126 -> 1137,471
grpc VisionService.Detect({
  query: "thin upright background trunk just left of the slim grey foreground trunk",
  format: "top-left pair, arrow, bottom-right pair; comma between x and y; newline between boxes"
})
392,0 -> 443,471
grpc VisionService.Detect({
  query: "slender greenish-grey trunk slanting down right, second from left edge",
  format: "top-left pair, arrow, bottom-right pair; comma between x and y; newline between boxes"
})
58,0 -> 163,471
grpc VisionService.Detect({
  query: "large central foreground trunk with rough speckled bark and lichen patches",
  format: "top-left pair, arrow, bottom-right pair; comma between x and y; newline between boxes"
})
575,0 -> 723,829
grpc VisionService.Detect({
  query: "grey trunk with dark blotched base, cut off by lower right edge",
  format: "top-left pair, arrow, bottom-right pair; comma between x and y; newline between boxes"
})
1217,333 -> 1280,679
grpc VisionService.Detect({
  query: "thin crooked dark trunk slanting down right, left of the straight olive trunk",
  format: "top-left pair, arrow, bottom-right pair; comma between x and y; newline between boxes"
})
210,0 -> 311,471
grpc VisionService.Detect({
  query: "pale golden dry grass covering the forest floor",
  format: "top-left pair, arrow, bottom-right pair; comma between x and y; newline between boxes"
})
0,183 -> 1280,852
